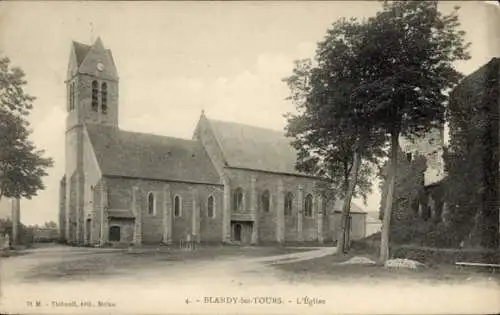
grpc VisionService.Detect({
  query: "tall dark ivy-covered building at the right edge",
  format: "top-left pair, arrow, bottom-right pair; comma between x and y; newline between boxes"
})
444,57 -> 500,248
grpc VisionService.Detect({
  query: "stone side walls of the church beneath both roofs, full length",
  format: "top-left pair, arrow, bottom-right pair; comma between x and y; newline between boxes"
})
85,169 -> 365,244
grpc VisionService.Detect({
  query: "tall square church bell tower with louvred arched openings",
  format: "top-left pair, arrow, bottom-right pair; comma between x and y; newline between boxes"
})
60,38 -> 118,244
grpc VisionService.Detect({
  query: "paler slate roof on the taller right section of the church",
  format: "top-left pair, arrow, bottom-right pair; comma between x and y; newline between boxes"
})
208,119 -> 305,175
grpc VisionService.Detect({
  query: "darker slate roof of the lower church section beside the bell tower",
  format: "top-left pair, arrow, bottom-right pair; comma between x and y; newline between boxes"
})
87,124 -> 220,184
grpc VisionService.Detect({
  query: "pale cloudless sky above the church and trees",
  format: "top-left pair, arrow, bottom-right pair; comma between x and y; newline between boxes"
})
0,1 -> 500,224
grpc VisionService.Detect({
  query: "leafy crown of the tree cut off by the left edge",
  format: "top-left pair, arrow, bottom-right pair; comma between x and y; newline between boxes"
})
0,57 -> 53,199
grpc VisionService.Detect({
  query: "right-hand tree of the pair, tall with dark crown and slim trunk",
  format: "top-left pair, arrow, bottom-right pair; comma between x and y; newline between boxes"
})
355,1 -> 470,262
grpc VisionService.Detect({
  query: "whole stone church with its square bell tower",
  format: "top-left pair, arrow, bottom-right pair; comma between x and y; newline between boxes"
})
59,38 -> 364,246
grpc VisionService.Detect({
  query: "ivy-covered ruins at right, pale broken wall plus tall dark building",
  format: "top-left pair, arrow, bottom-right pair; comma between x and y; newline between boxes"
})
380,58 -> 500,247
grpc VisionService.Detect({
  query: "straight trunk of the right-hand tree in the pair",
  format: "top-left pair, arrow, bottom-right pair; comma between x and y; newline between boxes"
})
380,130 -> 399,263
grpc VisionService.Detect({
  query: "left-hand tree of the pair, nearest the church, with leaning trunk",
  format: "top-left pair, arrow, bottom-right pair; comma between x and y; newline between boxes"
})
285,19 -> 385,253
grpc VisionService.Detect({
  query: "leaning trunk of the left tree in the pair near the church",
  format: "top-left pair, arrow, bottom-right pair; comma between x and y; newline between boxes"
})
337,150 -> 361,254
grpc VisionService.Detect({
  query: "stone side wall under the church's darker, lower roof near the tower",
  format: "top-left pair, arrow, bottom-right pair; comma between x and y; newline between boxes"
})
106,177 -> 222,244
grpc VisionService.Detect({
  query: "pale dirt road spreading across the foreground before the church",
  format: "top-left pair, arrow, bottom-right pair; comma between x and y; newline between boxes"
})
0,248 -> 500,314
